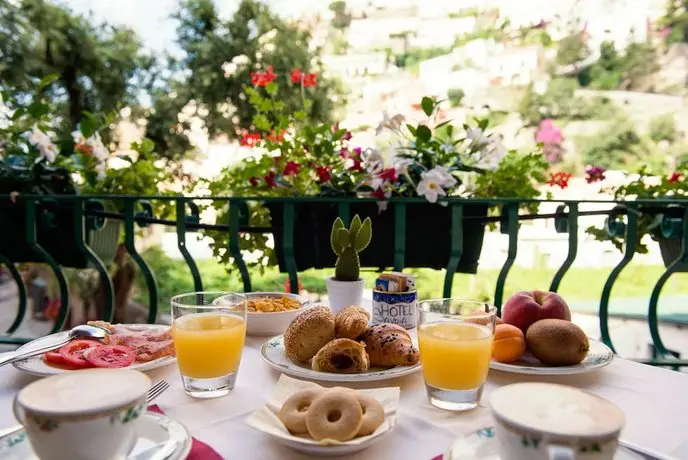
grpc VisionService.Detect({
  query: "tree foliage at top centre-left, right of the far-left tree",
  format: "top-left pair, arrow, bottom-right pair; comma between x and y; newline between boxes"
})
147,0 -> 335,157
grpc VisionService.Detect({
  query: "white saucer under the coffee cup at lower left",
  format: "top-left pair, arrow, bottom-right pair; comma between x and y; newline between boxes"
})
0,412 -> 192,460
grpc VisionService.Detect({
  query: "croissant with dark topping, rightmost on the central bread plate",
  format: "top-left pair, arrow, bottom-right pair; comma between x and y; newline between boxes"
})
360,323 -> 420,367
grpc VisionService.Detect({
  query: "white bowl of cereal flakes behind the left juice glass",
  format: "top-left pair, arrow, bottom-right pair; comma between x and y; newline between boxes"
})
220,292 -> 310,336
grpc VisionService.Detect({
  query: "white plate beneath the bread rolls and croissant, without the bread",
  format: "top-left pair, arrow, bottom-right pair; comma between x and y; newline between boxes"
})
260,335 -> 420,383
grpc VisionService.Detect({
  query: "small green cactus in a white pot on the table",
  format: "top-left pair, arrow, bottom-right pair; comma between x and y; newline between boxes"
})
327,214 -> 373,314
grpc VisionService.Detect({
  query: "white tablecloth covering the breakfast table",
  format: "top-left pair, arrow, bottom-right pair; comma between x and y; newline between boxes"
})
0,337 -> 688,460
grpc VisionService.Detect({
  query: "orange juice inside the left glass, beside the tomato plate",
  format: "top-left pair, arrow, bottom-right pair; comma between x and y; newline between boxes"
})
172,313 -> 246,379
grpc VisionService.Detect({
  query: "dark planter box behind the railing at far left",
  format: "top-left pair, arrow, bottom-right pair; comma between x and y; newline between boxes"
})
0,164 -> 87,268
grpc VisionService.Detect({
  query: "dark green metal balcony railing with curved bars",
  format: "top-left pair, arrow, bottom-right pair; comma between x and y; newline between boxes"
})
0,195 -> 688,368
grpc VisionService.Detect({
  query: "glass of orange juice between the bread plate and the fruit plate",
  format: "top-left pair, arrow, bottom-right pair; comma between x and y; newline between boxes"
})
418,299 -> 497,411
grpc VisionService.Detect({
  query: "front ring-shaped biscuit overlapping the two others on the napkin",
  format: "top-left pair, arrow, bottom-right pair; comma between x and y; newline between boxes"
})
306,391 -> 363,441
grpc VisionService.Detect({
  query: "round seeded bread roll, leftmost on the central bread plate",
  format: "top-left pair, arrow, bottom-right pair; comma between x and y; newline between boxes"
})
284,307 -> 334,362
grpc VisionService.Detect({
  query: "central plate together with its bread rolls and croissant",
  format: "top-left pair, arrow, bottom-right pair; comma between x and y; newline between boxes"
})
261,306 -> 420,382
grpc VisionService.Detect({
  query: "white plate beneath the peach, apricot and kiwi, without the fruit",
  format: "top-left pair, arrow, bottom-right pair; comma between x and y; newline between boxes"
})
490,338 -> 614,375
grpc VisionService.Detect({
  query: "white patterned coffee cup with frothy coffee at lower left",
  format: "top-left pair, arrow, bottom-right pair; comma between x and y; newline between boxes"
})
14,369 -> 151,460
